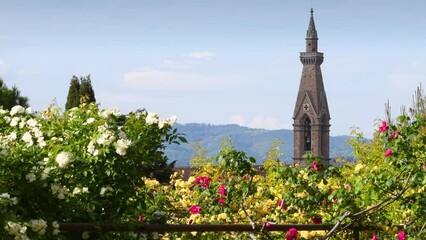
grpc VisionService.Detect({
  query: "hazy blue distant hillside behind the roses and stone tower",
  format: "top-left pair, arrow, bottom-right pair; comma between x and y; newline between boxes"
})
166,123 -> 353,166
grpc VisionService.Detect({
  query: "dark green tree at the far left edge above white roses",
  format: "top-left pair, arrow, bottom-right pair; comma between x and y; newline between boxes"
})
0,78 -> 29,110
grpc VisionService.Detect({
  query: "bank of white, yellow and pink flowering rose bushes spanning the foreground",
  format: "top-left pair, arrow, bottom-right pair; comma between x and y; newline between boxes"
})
0,85 -> 426,240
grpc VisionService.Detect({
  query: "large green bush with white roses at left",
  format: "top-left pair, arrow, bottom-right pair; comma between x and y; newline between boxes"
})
0,104 -> 186,239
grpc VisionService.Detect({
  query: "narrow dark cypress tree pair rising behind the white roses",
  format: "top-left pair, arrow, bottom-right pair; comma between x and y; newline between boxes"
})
65,75 -> 96,110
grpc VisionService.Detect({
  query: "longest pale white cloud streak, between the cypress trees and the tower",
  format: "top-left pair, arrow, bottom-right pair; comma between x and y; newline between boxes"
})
124,69 -> 239,91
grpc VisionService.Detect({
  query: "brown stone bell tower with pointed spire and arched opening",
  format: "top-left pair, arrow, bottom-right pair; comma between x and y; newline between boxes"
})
293,9 -> 330,164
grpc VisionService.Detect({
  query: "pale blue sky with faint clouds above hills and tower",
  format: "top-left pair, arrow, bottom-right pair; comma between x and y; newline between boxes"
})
0,0 -> 426,137
